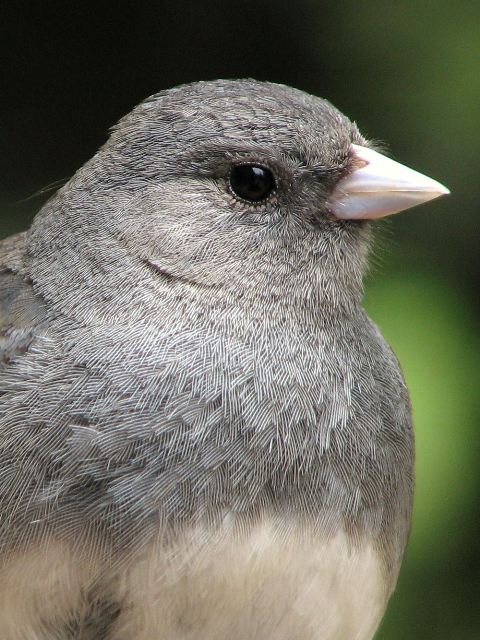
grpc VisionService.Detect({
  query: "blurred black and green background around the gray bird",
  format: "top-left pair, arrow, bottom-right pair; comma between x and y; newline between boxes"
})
0,0 -> 480,640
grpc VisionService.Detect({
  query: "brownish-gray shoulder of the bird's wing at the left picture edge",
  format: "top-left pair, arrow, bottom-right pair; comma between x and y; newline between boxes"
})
0,232 -> 45,367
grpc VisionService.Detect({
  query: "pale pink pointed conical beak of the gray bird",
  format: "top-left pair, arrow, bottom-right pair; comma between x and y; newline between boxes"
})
329,144 -> 450,220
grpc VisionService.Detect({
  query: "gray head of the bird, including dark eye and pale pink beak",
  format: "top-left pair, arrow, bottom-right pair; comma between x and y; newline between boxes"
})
31,80 -> 447,320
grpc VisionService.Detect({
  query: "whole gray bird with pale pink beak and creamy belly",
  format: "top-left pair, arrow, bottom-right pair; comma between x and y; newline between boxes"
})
0,79 -> 448,640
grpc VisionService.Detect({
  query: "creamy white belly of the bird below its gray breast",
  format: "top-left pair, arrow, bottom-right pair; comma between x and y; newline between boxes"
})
0,523 -> 389,640
